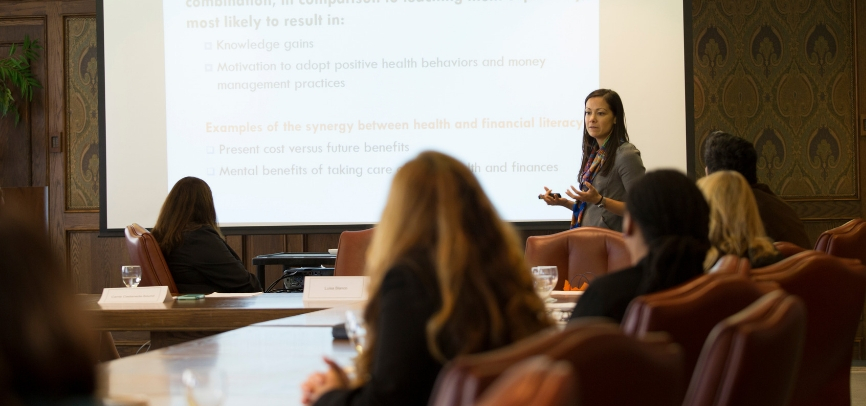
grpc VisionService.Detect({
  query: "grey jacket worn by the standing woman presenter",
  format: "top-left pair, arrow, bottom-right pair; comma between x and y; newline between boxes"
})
581,142 -> 646,231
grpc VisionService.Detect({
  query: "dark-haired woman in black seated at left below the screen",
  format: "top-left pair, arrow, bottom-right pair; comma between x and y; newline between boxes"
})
152,176 -> 262,293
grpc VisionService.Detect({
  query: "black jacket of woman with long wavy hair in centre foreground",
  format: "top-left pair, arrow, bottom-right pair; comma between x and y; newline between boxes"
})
316,265 -> 442,406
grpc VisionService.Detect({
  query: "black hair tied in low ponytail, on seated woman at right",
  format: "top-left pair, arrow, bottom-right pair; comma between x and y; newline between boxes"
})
626,170 -> 710,294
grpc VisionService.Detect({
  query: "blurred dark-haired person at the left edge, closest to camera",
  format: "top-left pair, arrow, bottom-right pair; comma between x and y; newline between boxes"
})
0,207 -> 98,405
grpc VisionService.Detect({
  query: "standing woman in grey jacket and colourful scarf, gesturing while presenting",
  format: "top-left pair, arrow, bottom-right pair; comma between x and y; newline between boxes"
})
543,89 -> 646,231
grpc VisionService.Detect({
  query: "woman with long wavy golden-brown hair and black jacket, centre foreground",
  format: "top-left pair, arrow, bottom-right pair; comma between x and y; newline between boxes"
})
302,152 -> 550,405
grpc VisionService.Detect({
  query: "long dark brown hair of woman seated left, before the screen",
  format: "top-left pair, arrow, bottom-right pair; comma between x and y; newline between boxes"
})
152,176 -> 222,255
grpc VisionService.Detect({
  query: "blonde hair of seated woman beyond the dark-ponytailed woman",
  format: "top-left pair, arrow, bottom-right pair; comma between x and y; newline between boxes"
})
698,171 -> 782,269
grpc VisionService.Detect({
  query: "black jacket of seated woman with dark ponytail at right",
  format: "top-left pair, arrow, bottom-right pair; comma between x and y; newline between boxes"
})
571,258 -> 647,323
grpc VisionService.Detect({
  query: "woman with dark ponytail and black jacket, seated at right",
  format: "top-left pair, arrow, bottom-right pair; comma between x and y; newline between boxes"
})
571,170 -> 710,322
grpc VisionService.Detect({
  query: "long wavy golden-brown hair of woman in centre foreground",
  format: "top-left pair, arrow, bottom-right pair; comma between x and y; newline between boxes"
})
358,151 -> 550,381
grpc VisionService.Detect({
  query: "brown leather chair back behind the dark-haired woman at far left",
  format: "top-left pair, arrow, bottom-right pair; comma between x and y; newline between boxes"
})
126,223 -> 178,295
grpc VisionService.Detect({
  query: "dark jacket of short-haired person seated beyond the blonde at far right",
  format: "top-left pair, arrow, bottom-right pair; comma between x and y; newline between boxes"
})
752,183 -> 812,249
